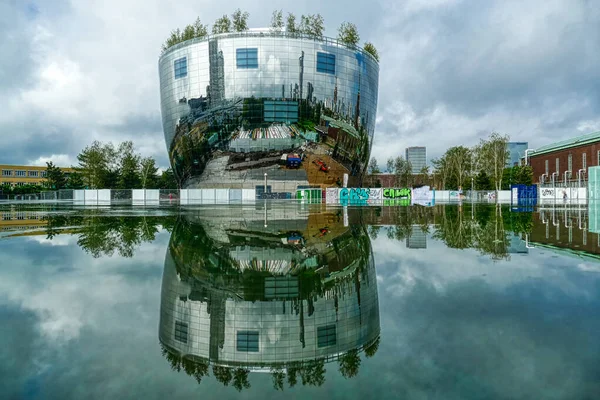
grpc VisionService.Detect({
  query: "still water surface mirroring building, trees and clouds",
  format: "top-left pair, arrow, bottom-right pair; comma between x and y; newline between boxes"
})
0,203 -> 600,399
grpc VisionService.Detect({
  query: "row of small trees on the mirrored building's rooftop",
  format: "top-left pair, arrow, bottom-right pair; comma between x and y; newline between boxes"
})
162,8 -> 379,61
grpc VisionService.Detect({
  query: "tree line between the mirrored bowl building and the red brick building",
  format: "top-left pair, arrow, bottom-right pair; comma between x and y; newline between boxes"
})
368,132 -> 533,190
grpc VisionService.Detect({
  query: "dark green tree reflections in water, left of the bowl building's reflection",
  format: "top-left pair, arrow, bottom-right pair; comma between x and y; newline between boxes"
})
46,214 -> 175,258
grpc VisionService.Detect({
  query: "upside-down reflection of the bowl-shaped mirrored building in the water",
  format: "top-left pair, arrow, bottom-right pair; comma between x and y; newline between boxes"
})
159,208 -> 380,386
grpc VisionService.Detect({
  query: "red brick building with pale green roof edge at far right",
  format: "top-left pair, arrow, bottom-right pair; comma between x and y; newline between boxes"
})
528,132 -> 600,186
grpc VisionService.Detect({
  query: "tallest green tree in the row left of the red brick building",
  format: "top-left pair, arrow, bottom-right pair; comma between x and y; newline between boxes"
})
475,132 -> 510,191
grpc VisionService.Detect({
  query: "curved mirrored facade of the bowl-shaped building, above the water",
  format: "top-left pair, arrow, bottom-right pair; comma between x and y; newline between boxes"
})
159,31 -> 379,193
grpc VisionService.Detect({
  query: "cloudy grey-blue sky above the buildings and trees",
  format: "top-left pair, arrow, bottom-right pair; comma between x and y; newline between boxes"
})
0,0 -> 600,167
